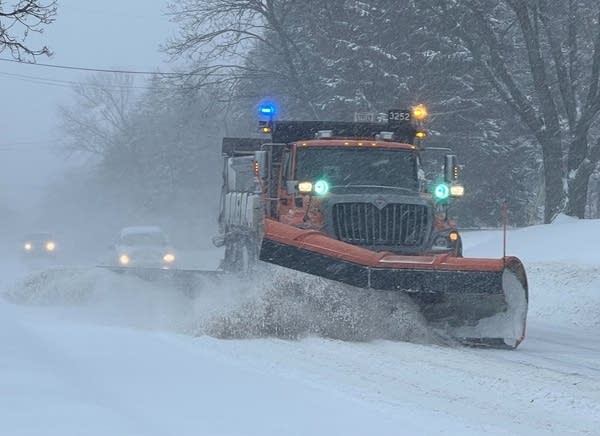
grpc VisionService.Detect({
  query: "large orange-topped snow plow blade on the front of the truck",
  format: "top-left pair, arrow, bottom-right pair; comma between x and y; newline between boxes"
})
260,219 -> 529,348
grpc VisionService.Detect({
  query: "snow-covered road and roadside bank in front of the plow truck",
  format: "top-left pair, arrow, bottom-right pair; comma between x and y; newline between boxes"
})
0,221 -> 600,436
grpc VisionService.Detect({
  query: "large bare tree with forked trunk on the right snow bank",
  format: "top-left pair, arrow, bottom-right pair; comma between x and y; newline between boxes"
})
433,0 -> 600,222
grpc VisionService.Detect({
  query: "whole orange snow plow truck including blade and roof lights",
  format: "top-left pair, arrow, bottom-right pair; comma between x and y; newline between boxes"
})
215,104 -> 528,348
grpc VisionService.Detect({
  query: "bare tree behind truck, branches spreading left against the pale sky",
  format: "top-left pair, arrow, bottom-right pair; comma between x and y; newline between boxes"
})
165,0 -> 317,116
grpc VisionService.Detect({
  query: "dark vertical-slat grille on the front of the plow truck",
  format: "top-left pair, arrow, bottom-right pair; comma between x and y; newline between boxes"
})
333,203 -> 429,247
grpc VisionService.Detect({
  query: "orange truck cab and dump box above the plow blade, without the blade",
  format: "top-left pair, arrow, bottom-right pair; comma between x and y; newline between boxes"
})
219,108 -> 462,268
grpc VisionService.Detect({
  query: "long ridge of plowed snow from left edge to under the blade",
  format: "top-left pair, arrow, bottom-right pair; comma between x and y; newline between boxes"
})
4,268 -> 432,342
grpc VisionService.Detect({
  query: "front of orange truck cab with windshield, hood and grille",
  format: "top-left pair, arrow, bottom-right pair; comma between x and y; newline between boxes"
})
278,138 -> 434,254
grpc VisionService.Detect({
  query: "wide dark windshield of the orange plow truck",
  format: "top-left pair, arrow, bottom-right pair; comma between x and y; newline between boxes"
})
296,147 -> 418,190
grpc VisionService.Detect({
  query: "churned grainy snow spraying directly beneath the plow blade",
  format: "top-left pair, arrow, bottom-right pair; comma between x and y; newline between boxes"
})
196,270 -> 432,342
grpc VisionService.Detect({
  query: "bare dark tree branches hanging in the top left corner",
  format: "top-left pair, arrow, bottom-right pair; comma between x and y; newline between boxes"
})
0,0 -> 57,60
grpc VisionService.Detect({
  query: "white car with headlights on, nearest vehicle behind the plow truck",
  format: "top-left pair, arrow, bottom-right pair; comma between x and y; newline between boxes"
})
114,226 -> 175,269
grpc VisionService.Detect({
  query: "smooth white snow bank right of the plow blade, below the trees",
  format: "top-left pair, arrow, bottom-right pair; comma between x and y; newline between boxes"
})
463,215 -> 600,329
